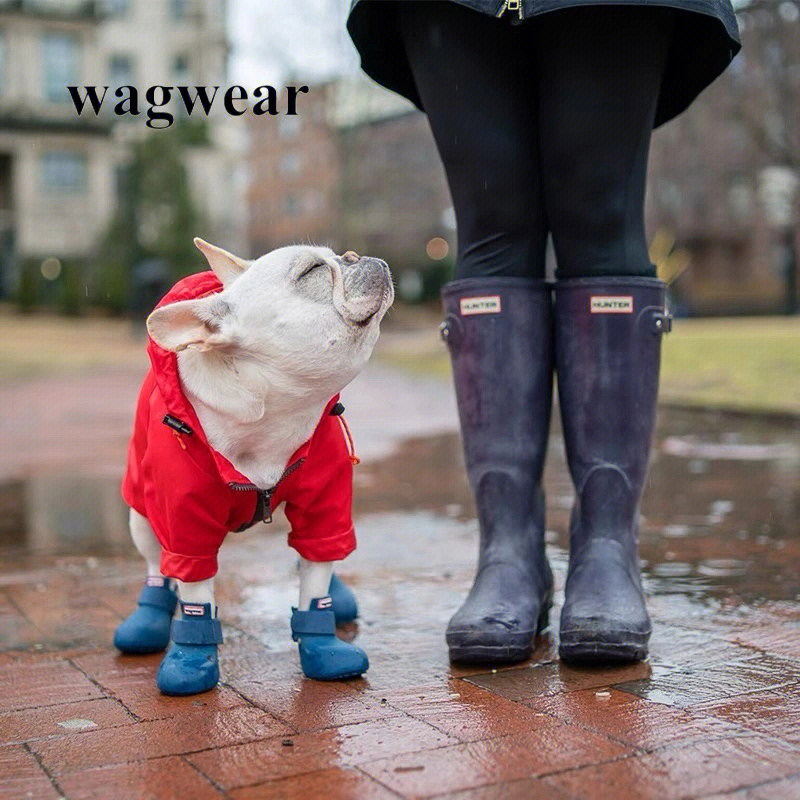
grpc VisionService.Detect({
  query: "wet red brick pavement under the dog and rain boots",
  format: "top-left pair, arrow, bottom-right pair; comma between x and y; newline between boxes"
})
0,358 -> 800,800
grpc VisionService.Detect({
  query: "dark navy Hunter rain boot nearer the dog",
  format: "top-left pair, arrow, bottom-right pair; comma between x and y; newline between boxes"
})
442,278 -> 553,664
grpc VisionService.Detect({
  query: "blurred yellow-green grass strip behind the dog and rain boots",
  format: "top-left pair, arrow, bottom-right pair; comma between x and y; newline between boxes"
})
0,307 -> 800,414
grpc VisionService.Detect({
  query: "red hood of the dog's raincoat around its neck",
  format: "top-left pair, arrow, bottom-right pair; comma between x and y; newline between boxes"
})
147,270 -> 332,484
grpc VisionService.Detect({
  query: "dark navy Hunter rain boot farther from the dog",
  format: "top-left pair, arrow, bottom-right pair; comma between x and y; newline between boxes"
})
555,278 -> 671,664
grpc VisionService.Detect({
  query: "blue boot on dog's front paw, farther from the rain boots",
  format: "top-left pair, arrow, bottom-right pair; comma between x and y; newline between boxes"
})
156,602 -> 222,695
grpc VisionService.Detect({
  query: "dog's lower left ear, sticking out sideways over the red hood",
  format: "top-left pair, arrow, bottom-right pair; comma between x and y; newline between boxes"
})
147,297 -> 231,353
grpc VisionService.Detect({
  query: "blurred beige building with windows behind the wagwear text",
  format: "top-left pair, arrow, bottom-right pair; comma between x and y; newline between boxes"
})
0,0 -> 246,294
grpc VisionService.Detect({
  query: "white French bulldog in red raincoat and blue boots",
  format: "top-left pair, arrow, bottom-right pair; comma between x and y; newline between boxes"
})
115,239 -> 394,694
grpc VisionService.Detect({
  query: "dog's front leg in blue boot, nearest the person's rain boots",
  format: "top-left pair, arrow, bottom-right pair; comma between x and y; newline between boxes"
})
292,558 -> 369,681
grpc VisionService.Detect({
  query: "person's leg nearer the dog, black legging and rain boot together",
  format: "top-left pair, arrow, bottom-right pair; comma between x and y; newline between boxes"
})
398,2 -> 552,663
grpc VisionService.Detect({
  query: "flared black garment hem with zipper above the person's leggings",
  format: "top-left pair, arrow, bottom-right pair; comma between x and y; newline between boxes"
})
347,0 -> 742,127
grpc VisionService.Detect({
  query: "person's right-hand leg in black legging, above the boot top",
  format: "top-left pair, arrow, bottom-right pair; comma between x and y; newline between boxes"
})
529,6 -> 673,279
